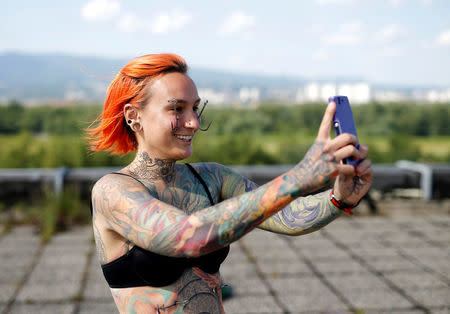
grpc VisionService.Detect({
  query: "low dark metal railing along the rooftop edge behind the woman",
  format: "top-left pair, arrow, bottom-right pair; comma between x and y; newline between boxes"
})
0,161 -> 450,200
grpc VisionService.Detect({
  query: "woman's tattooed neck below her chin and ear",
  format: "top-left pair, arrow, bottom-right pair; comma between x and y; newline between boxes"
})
128,152 -> 175,183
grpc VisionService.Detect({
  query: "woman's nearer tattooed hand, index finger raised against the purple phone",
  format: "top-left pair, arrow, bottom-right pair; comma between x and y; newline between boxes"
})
294,102 -> 361,195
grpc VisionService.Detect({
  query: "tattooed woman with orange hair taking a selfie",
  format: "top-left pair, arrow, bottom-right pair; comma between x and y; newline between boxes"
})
90,54 -> 372,313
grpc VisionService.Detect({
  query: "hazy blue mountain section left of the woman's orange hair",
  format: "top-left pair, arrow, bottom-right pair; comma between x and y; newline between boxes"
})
0,53 -> 123,101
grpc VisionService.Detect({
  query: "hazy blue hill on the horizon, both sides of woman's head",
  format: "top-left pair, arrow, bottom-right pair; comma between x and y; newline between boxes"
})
0,52 -> 310,102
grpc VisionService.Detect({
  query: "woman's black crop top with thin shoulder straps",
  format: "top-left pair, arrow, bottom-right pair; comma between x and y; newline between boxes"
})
95,164 -> 230,288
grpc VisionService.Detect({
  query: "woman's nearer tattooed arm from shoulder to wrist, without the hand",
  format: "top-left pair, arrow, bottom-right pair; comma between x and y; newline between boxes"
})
98,169 -> 294,256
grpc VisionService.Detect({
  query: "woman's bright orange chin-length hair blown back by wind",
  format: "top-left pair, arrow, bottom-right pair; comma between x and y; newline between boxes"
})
87,54 -> 187,154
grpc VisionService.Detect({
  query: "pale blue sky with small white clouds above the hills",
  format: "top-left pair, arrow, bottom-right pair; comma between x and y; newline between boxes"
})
0,0 -> 450,87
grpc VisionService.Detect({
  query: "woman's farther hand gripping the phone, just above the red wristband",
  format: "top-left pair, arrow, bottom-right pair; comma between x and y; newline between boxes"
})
333,144 -> 372,204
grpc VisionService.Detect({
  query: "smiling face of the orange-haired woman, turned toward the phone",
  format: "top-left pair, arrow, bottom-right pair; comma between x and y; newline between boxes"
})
139,72 -> 200,160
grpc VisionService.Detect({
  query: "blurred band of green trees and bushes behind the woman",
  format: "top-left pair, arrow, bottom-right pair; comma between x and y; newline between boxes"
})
0,102 -> 450,168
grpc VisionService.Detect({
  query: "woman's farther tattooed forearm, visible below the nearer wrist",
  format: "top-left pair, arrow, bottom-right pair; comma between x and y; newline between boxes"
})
259,191 -> 340,235
